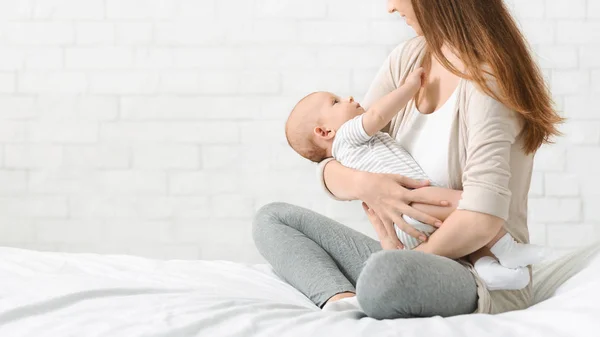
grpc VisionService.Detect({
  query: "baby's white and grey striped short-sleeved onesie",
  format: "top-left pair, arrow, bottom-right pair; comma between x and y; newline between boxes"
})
331,115 -> 436,249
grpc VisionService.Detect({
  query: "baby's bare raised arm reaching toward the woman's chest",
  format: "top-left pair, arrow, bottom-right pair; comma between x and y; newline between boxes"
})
363,68 -> 424,136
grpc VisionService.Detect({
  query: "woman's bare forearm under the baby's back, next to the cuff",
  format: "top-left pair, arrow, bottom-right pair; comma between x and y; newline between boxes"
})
323,160 -> 361,200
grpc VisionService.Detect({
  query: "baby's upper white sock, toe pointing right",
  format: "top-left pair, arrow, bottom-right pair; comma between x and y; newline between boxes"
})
490,233 -> 548,268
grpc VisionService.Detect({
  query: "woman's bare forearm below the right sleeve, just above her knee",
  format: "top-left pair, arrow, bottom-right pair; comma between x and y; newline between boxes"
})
415,210 -> 504,259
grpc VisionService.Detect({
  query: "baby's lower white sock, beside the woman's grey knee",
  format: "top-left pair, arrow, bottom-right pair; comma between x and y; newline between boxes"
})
473,256 -> 530,290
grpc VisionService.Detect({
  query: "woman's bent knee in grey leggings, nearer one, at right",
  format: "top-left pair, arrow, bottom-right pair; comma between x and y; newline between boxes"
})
356,250 -> 477,319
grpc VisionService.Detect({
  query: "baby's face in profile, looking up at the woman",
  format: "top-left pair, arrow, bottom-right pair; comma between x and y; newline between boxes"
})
318,92 -> 365,131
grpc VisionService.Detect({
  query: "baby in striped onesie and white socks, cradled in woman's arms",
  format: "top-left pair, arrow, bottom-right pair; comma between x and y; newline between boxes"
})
286,68 -> 545,290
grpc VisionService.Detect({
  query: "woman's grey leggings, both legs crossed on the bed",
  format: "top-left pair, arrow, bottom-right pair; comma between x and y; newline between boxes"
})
253,203 -> 477,319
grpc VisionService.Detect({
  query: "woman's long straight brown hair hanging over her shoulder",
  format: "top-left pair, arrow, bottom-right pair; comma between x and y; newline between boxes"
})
412,0 -> 563,153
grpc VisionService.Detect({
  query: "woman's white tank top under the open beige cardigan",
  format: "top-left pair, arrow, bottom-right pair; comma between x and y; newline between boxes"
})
397,88 -> 458,187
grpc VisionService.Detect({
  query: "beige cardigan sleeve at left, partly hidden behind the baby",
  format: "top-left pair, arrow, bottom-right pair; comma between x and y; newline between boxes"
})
317,43 -> 405,200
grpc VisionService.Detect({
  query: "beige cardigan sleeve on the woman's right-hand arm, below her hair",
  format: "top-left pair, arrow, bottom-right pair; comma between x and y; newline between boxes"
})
458,88 -> 523,221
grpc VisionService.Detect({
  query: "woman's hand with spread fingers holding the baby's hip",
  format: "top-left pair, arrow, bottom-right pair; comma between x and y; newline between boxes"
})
358,172 -> 448,248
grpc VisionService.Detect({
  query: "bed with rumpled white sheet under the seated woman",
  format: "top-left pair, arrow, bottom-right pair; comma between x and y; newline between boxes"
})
0,244 -> 600,337
